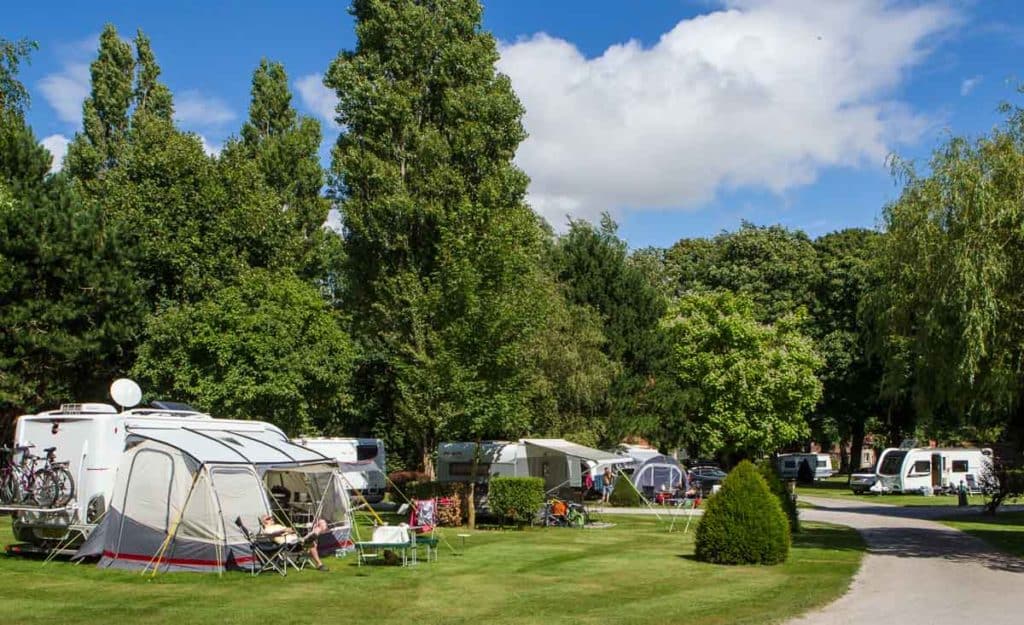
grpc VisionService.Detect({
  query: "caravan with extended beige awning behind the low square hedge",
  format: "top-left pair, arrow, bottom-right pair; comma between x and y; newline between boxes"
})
437,439 -> 635,491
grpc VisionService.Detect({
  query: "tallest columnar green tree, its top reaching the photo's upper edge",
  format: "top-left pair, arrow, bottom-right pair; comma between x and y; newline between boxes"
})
325,0 -> 550,472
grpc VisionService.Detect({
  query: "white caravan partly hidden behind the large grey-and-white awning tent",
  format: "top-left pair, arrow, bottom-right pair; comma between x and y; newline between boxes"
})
293,438 -> 387,503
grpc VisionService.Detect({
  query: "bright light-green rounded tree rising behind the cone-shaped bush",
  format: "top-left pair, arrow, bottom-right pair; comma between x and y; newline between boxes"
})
666,292 -> 821,457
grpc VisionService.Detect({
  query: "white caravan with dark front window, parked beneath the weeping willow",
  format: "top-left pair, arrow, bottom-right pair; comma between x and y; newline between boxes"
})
870,447 -> 992,494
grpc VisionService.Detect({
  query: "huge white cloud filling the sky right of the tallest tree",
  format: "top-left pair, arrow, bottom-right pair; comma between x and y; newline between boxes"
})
499,0 -> 957,223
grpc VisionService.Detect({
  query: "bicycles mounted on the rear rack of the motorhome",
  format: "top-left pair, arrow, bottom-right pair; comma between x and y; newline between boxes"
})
0,445 -> 75,508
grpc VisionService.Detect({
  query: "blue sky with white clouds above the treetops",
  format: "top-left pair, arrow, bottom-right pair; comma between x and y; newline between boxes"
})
8,0 -> 1024,247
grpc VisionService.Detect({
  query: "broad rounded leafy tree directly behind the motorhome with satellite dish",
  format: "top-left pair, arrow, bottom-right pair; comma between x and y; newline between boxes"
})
133,269 -> 354,435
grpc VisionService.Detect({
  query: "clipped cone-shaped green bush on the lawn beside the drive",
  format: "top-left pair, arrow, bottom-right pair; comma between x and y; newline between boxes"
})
696,460 -> 791,565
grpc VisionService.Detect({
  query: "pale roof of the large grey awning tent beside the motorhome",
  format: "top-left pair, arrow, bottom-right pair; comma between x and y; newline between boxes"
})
123,428 -> 330,466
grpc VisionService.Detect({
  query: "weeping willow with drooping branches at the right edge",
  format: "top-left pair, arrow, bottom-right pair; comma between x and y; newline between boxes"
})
869,103 -> 1024,452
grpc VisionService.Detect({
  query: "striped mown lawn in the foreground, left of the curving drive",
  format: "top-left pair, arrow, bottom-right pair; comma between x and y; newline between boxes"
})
0,510 -> 863,625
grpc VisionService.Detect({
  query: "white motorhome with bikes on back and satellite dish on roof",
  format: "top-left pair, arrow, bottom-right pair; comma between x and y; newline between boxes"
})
7,402 -> 326,544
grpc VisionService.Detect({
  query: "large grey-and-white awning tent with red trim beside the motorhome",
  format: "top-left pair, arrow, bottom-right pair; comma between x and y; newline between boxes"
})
76,427 -> 352,572
